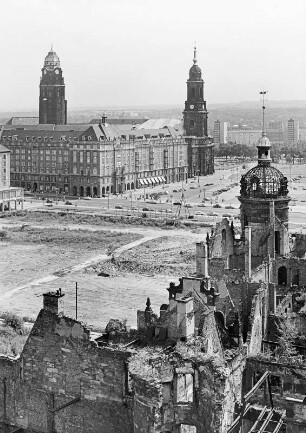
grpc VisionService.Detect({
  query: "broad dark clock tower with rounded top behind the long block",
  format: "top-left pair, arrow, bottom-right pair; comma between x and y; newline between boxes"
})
39,47 -> 67,125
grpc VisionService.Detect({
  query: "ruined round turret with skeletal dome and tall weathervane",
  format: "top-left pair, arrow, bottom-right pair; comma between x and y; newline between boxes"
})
238,92 -> 290,267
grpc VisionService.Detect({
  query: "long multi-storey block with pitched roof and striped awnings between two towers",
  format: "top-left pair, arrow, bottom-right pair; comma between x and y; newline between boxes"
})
1,124 -> 188,197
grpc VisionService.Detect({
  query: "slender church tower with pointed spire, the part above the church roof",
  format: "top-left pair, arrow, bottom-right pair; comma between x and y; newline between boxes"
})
183,47 -> 208,137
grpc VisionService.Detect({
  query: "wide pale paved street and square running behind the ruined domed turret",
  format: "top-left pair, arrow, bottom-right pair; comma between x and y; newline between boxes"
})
25,163 -> 306,230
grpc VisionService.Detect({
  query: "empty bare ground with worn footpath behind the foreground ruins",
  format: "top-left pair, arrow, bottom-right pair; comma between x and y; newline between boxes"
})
0,214 -> 206,328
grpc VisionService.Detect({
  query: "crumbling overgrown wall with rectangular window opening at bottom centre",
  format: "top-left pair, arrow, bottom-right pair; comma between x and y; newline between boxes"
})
130,346 -> 244,433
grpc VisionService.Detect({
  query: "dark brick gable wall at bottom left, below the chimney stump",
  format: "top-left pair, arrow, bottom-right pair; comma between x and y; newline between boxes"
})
0,310 -> 133,433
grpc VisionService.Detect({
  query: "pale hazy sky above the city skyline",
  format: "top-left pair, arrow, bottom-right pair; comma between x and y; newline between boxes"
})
0,0 -> 306,111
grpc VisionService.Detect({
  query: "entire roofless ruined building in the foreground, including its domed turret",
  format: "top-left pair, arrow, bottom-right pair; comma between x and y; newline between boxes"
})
0,109 -> 306,433
